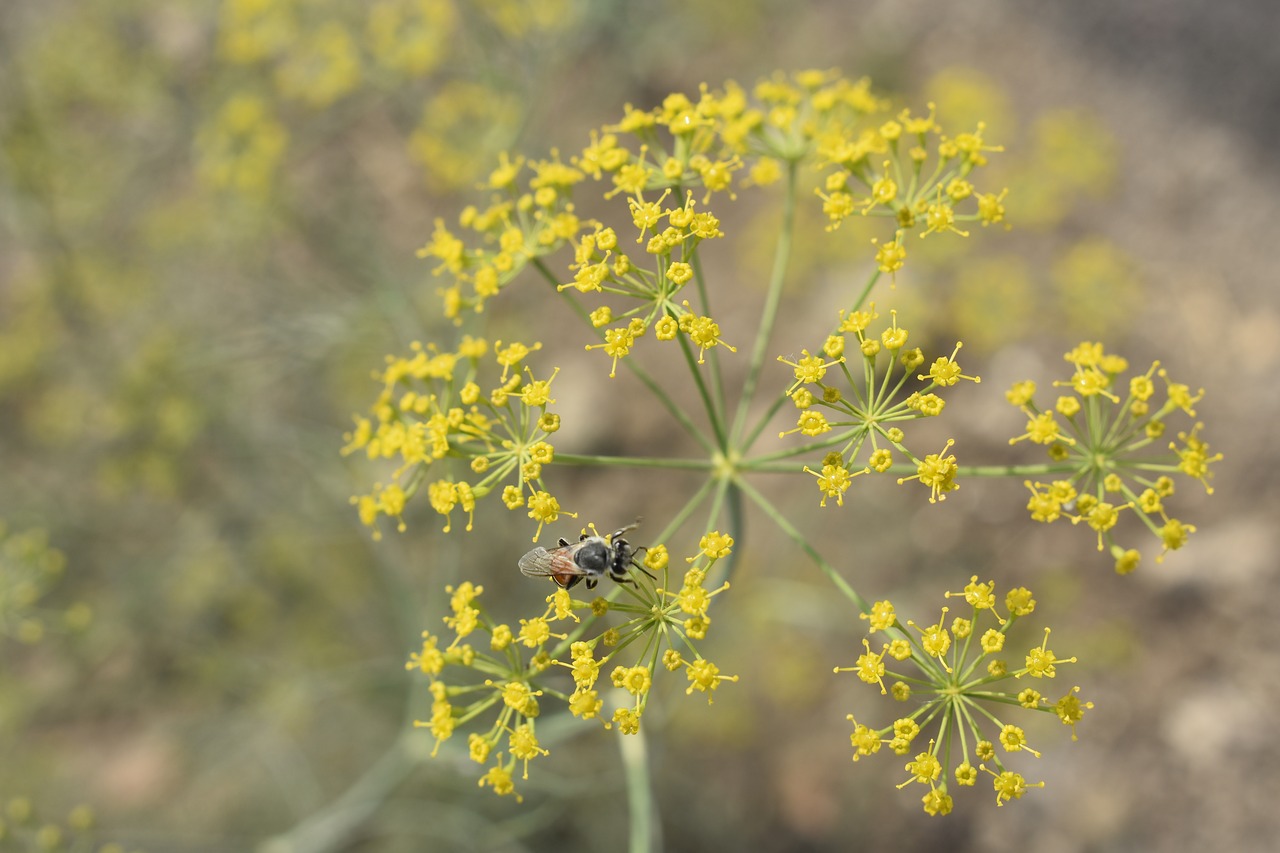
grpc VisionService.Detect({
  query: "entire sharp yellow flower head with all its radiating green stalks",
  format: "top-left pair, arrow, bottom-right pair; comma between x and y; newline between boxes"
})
347,72 -> 1221,815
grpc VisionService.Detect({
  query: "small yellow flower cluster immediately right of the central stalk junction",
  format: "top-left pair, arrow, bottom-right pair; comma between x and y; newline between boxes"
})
778,302 -> 980,506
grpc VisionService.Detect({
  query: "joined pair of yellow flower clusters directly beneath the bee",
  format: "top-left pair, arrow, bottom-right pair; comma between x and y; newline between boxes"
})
406,526 -> 737,799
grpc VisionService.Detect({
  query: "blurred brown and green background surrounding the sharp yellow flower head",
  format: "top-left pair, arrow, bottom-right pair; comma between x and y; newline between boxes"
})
0,0 -> 1280,853
